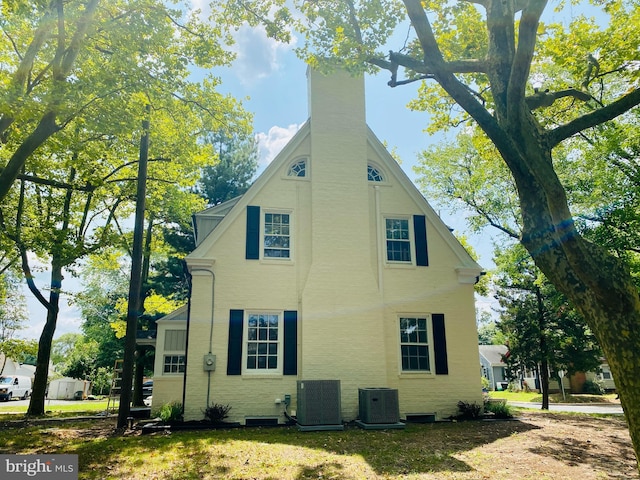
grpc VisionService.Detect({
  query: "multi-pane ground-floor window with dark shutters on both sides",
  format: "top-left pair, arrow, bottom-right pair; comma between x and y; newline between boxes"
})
247,313 -> 280,371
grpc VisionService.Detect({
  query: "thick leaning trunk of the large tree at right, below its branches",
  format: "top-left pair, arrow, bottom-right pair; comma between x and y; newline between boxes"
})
510,125 -> 640,464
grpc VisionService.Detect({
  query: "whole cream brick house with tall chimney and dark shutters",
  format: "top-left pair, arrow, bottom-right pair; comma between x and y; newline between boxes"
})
153,70 -> 482,423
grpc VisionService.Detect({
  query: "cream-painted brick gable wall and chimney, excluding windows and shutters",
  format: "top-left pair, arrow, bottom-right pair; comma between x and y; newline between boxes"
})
170,68 -> 481,422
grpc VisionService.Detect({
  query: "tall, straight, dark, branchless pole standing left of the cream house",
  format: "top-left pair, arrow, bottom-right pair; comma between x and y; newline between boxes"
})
117,105 -> 151,428
